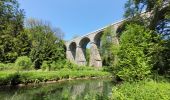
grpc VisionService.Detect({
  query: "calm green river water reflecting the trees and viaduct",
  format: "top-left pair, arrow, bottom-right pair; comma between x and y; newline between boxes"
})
0,79 -> 113,100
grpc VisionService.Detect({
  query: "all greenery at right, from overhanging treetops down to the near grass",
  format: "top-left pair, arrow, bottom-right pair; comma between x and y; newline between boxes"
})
112,0 -> 170,100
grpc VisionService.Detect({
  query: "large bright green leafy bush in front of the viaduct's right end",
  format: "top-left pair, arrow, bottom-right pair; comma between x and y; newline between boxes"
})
115,25 -> 159,81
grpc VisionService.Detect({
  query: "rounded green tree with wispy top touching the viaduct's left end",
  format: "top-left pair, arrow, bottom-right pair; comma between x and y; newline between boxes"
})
26,19 -> 65,69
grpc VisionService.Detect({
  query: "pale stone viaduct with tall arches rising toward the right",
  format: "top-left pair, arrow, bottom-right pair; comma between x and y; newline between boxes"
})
66,21 -> 123,67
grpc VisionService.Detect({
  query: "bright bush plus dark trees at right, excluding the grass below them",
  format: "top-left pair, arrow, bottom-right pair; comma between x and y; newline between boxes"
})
110,0 -> 170,81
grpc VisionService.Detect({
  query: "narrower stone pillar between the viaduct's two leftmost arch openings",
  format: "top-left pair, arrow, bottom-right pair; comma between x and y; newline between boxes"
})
76,46 -> 86,66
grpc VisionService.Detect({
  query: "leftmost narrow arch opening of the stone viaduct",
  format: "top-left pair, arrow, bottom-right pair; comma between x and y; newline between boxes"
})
69,42 -> 77,61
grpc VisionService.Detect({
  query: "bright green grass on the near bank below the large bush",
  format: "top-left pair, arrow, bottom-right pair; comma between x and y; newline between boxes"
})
112,80 -> 170,100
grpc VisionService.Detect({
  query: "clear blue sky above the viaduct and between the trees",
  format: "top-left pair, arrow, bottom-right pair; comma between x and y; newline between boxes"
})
18,0 -> 127,40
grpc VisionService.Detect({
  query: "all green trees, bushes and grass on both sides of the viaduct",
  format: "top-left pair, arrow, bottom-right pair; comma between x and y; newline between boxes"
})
0,0 -> 170,100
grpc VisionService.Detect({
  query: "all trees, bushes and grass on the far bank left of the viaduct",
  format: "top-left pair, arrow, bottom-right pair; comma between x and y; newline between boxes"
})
0,0 -> 110,85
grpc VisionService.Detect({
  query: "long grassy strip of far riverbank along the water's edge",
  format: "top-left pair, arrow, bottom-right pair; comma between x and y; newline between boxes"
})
0,70 -> 111,86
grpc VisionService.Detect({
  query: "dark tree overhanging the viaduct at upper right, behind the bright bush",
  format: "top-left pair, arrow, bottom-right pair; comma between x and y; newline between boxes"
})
122,0 -> 170,74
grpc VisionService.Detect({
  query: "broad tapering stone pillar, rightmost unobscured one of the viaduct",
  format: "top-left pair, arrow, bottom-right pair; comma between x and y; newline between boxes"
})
89,42 -> 102,68
